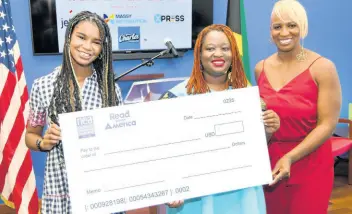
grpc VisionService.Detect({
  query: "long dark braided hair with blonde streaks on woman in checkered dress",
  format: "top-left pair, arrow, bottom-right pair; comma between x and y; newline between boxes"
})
48,11 -> 119,124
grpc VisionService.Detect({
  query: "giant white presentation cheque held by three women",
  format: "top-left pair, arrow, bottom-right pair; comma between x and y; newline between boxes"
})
60,87 -> 272,214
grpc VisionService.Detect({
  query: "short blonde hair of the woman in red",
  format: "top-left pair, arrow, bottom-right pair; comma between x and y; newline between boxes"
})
271,0 -> 308,39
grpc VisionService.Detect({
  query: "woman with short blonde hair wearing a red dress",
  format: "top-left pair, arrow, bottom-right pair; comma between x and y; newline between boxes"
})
255,0 -> 341,214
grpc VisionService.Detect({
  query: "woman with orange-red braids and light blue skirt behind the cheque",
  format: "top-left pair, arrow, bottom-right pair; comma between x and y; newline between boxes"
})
162,25 -> 280,214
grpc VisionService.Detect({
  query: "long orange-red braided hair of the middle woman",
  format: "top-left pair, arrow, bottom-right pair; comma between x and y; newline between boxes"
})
187,24 -> 247,94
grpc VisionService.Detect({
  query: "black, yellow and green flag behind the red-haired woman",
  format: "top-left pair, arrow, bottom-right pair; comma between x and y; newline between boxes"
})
227,0 -> 252,85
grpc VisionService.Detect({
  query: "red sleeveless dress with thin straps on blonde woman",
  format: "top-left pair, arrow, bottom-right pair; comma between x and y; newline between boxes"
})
258,57 -> 334,214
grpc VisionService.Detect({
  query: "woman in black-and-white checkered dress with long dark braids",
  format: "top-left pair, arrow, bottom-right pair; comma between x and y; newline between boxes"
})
26,11 -> 122,214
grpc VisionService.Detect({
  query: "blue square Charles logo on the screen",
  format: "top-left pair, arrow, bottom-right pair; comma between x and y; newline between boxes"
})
117,26 -> 141,50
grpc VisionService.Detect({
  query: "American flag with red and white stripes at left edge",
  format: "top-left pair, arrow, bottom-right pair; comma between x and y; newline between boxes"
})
0,0 -> 39,214
